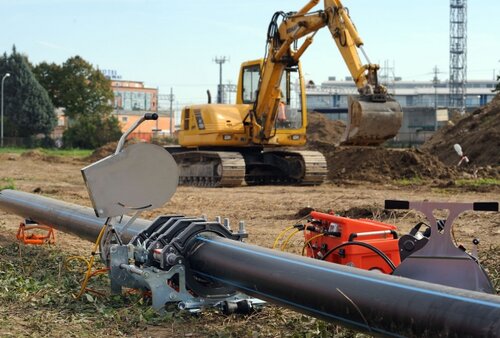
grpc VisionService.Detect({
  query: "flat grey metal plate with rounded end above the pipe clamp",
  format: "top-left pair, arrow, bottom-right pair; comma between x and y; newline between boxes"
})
81,143 -> 179,217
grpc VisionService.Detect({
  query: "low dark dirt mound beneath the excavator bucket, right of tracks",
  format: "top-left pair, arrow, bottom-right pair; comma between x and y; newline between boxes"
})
306,143 -> 456,183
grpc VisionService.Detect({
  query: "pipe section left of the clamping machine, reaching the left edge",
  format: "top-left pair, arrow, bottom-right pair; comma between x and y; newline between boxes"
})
0,189 -> 151,242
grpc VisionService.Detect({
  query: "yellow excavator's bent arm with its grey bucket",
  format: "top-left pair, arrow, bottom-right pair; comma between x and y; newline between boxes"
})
250,0 -> 402,145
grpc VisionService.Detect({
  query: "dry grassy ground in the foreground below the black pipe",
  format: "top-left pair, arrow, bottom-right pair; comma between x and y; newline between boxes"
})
0,242 -> 360,338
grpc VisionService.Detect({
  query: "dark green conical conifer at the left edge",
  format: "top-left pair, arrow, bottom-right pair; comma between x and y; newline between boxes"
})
0,46 -> 57,137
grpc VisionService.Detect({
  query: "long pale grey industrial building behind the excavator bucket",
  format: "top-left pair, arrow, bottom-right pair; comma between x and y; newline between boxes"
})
306,77 -> 496,145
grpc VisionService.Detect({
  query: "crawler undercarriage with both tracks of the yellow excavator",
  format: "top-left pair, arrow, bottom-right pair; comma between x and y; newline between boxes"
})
172,148 -> 327,187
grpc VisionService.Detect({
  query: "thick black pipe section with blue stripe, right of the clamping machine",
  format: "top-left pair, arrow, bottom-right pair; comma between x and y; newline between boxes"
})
187,235 -> 500,337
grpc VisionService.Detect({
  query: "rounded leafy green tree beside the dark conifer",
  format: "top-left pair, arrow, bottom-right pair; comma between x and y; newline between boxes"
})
34,56 -> 121,148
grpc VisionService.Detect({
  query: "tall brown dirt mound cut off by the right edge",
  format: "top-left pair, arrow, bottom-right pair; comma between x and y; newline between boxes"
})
422,94 -> 500,166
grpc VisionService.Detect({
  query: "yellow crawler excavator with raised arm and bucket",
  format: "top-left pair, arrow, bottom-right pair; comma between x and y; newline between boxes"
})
167,0 -> 402,187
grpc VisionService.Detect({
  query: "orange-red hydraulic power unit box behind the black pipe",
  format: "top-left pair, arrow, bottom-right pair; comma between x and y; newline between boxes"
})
304,211 -> 401,274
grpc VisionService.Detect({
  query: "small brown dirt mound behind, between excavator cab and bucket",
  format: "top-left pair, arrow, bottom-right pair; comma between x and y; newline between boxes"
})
307,112 -> 345,145
